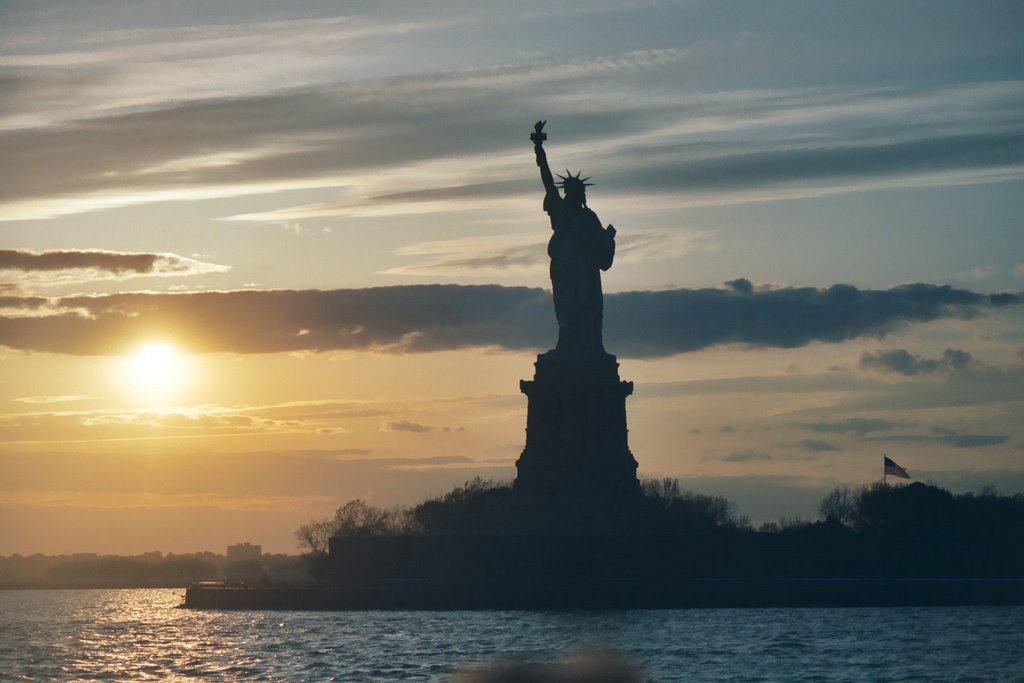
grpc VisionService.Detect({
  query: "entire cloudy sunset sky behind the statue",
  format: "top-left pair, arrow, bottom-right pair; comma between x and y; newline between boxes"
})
0,0 -> 1024,555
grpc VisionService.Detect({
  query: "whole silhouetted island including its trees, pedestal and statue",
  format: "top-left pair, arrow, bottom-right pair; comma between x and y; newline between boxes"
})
184,121 -> 1024,609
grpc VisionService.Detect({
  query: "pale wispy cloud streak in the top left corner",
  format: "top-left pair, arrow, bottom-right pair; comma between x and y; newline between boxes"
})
0,8 -> 456,128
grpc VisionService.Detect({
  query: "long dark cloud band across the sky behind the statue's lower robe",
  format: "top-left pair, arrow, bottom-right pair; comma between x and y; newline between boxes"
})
0,284 -> 1021,357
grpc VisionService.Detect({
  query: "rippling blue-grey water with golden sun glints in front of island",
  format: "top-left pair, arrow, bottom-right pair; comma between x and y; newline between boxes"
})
0,590 -> 1024,682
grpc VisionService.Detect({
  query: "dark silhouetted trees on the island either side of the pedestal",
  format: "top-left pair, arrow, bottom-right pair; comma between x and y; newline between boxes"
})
296,477 -> 1024,578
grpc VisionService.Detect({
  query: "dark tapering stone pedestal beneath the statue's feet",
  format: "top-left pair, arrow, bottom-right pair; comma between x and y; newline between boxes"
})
515,353 -> 640,498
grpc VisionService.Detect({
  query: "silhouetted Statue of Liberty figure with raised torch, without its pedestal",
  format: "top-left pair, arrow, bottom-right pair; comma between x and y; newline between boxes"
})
529,121 -> 615,358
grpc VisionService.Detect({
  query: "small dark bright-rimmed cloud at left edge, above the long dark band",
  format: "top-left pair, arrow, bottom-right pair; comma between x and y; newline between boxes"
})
0,249 -> 229,286
